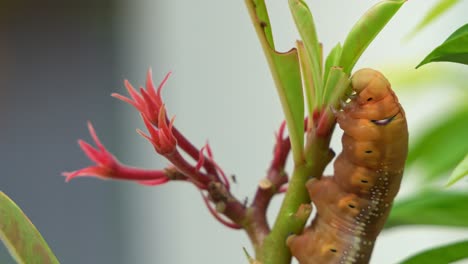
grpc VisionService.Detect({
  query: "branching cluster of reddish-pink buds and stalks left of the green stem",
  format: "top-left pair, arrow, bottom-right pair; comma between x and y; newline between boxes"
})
63,69 -> 245,228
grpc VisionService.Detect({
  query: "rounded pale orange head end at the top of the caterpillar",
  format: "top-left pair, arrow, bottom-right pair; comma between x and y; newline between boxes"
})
351,68 -> 391,104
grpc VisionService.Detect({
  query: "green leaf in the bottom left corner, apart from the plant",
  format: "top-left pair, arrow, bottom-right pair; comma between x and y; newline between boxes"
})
0,192 -> 59,264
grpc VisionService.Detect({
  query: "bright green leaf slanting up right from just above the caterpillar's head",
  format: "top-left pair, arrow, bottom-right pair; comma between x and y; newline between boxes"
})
338,0 -> 406,74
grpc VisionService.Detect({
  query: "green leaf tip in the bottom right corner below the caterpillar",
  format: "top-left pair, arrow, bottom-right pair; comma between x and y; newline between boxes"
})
400,240 -> 468,264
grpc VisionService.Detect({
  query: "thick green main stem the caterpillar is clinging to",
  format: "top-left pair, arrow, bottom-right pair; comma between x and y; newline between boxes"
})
257,135 -> 331,264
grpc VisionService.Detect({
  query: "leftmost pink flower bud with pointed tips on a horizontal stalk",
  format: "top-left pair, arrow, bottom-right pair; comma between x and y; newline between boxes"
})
62,122 -> 169,185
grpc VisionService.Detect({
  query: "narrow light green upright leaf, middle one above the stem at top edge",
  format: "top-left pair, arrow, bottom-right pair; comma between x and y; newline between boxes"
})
288,0 -> 322,108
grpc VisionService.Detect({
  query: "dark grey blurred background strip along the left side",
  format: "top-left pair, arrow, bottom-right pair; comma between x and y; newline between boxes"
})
0,0 -> 125,263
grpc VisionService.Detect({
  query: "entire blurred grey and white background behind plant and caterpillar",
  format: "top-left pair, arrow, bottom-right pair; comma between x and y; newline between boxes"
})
0,0 -> 468,264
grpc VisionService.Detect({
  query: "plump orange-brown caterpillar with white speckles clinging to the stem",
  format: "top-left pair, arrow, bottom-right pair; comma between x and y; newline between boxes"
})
286,69 -> 408,264
